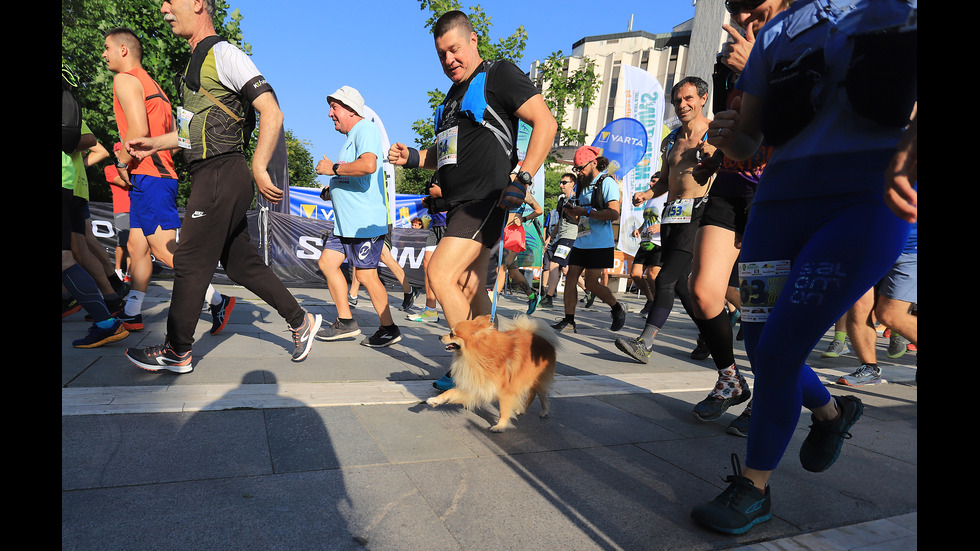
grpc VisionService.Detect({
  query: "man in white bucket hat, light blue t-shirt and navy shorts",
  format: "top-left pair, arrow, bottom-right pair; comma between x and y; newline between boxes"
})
316,86 -> 402,348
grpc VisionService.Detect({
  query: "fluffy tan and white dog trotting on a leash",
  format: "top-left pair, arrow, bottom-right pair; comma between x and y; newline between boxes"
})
426,315 -> 560,432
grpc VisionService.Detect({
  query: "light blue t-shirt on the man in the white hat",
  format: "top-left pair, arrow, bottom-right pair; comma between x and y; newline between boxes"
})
330,119 -> 388,238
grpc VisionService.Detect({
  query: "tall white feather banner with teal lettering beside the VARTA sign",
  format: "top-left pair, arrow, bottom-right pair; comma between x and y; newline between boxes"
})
617,65 -> 667,255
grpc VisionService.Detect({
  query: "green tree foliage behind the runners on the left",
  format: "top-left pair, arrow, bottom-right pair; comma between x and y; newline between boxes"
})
61,0 -> 313,206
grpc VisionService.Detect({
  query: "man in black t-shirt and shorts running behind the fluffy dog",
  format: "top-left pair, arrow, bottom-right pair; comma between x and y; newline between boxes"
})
388,11 -> 558,389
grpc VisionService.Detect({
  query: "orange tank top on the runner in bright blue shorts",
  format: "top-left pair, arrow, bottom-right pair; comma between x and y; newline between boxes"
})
112,67 -> 177,180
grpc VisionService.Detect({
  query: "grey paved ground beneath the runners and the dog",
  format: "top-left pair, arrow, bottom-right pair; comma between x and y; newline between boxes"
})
62,280 -> 918,551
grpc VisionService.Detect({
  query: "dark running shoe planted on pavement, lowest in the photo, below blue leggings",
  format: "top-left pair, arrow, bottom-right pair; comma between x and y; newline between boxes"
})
691,454 -> 772,534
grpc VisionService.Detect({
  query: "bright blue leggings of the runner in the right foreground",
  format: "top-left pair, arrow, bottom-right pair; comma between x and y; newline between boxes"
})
739,191 -> 909,471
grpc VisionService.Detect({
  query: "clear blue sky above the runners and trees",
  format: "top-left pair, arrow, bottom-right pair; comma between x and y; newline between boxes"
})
229,0 -> 696,187
